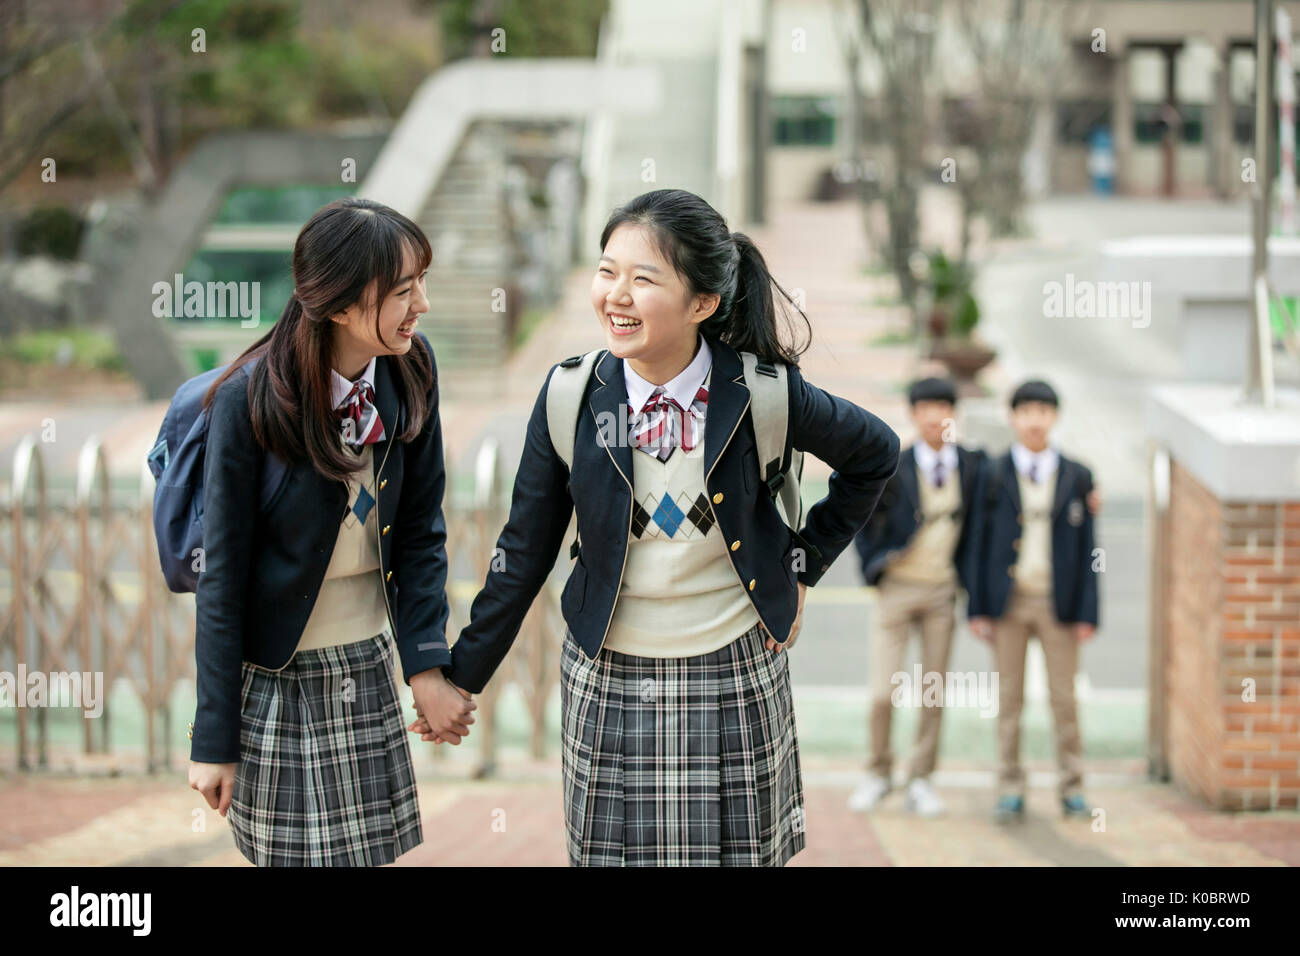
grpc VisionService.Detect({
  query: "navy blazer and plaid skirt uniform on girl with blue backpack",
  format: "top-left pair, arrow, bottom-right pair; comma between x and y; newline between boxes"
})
190,336 -> 450,866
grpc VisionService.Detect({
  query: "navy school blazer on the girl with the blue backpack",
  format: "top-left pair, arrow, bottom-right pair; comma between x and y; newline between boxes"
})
190,333 -> 451,763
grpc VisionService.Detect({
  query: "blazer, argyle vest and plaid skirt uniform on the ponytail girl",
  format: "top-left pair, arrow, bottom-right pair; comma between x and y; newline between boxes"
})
449,338 -> 898,865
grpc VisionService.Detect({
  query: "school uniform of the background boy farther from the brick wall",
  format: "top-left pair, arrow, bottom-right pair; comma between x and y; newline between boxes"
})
854,441 -> 983,780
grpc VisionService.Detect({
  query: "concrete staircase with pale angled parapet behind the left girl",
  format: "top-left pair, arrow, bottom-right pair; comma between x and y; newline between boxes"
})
358,57 -> 662,394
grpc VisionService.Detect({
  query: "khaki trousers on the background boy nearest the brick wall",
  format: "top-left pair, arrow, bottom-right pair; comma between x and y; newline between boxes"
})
993,588 -> 1083,797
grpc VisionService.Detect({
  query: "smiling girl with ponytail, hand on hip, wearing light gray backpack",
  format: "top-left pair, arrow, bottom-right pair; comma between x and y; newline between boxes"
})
417,190 -> 898,866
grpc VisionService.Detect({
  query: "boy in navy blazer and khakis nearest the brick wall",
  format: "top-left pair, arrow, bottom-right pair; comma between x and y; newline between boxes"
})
969,381 -> 1097,822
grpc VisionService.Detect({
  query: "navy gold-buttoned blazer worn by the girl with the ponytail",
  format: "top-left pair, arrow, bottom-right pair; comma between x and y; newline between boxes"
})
446,338 -> 898,693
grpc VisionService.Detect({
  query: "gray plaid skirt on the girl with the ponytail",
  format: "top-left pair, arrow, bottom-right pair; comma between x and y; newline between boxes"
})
560,624 -> 803,866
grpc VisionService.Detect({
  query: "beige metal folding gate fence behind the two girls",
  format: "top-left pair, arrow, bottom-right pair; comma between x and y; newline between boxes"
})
0,436 -> 564,774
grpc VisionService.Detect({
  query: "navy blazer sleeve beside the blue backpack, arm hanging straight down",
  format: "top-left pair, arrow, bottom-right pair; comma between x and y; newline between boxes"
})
190,375 -> 263,763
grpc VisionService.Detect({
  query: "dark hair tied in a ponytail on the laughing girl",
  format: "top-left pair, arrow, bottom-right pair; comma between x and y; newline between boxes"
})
601,189 -> 813,365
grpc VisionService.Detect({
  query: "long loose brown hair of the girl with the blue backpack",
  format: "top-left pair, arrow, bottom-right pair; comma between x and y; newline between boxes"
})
203,198 -> 434,480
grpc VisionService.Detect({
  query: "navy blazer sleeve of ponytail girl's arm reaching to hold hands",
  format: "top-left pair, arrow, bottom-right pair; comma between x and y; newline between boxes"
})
447,365 -> 573,693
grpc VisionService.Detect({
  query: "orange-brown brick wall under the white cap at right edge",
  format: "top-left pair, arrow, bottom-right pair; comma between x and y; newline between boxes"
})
1165,462 -> 1300,809
